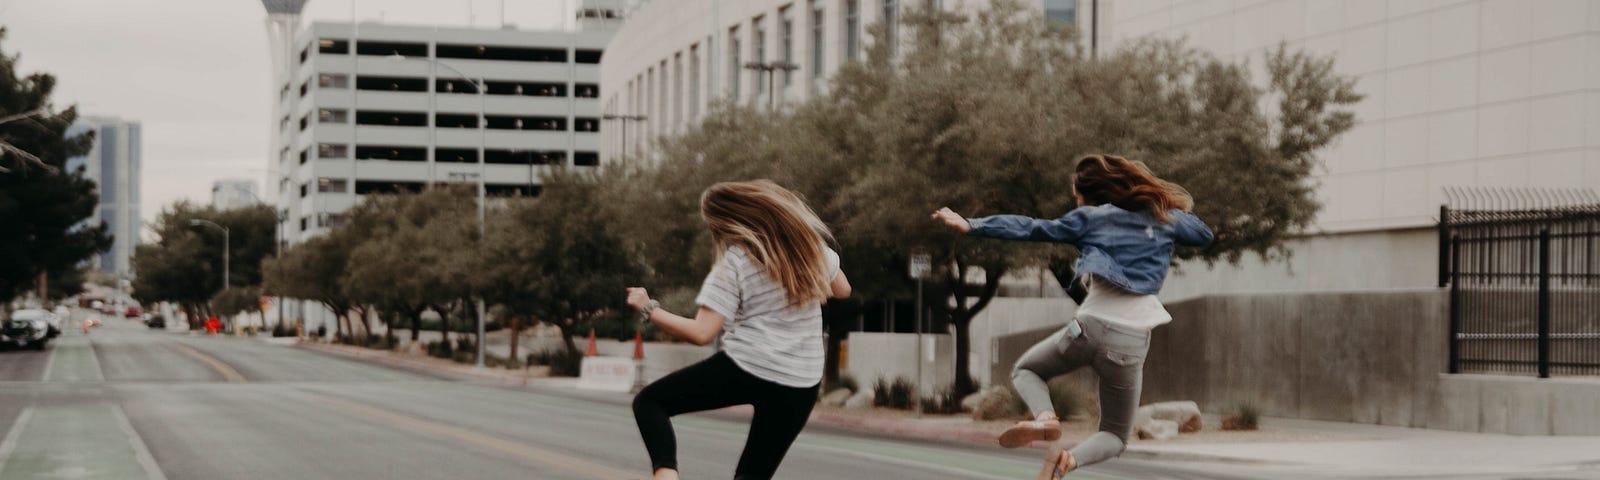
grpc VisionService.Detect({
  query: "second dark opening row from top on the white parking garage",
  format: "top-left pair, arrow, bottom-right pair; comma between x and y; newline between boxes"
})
296,74 -> 600,98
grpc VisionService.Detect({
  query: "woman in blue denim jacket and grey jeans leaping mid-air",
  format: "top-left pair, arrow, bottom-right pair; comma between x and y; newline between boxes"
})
933,155 -> 1211,480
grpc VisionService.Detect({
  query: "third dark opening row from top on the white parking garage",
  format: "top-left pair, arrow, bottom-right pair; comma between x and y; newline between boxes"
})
299,109 -> 600,133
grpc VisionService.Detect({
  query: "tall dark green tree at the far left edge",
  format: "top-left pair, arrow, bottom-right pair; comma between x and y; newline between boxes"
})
0,27 -> 110,304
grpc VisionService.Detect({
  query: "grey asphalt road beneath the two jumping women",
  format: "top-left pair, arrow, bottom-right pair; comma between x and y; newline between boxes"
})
0,318 -> 1299,480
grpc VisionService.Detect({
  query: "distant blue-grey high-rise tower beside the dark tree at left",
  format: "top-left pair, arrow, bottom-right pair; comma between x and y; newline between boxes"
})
67,115 -> 144,278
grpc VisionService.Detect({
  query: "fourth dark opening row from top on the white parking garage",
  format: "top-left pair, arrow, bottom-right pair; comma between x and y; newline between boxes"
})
299,144 -> 600,166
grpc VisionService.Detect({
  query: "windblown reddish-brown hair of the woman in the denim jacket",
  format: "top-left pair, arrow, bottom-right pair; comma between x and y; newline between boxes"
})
1072,154 -> 1195,224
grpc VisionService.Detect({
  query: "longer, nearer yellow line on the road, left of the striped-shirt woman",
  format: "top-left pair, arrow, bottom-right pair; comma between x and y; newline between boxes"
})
318,397 -> 643,480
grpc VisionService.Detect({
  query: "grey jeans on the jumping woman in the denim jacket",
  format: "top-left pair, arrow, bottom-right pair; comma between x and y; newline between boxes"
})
1011,315 -> 1150,467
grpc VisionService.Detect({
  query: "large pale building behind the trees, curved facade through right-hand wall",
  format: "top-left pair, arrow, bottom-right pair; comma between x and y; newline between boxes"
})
600,0 -> 1600,299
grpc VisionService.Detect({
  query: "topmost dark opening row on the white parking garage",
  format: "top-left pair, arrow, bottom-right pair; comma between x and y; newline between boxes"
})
301,38 -> 603,64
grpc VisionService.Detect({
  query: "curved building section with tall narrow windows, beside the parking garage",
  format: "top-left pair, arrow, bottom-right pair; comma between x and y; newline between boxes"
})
600,0 -> 1090,160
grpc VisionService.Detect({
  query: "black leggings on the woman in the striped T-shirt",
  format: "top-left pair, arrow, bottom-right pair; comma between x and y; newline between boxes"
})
634,352 -> 818,478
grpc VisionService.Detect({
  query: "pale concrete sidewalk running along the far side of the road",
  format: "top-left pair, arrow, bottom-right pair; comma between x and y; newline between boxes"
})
281,339 -> 1600,478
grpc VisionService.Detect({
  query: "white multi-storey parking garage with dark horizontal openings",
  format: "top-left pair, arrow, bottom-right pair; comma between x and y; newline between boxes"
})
266,0 -> 619,243
